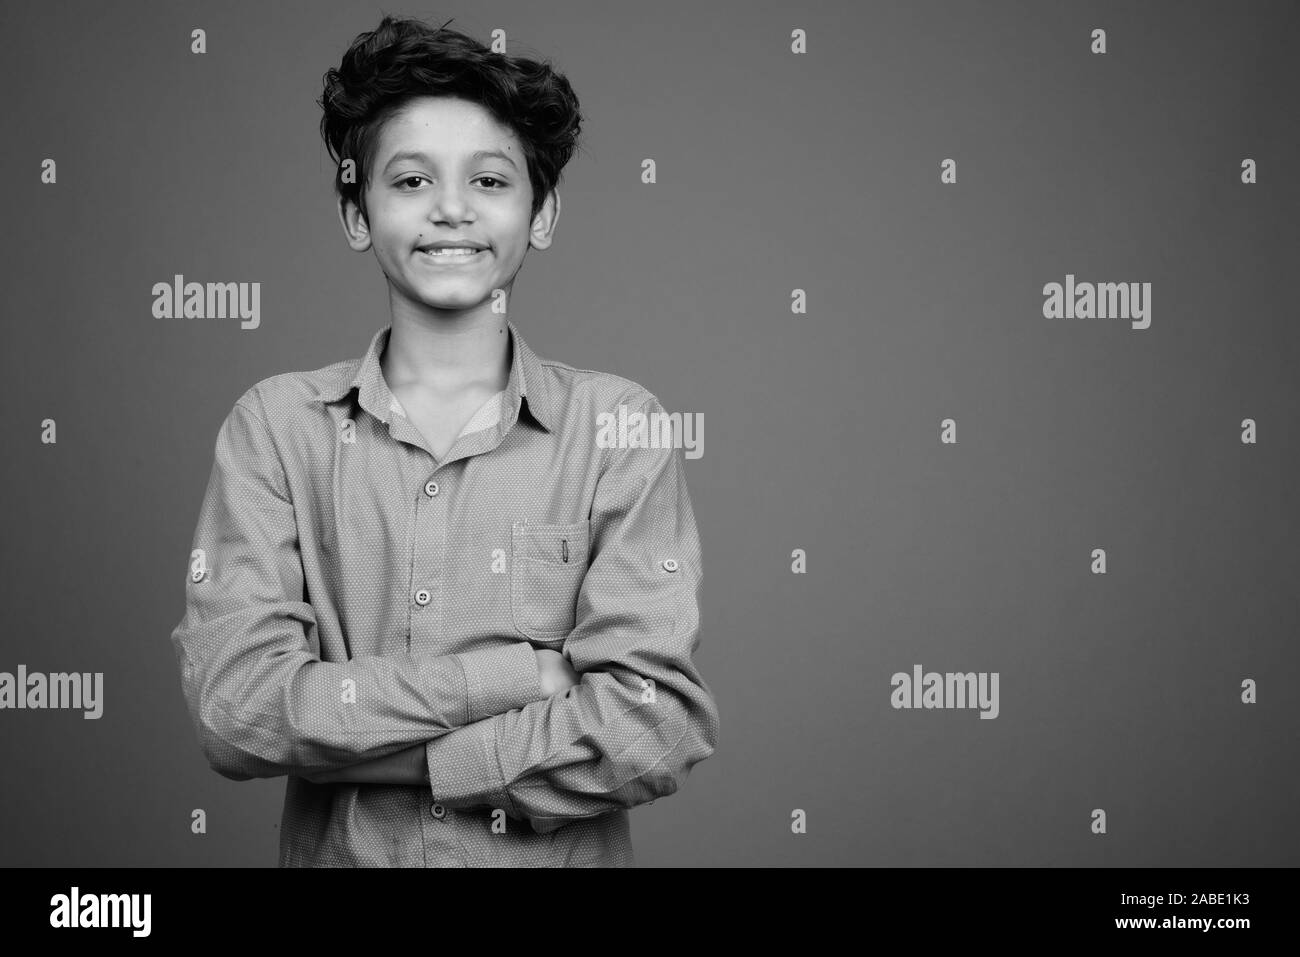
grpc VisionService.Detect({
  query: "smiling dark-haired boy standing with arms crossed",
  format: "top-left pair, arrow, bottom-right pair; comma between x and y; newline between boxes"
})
172,17 -> 719,867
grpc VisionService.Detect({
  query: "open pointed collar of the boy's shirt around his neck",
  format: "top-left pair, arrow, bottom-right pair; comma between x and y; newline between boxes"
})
317,320 -> 555,432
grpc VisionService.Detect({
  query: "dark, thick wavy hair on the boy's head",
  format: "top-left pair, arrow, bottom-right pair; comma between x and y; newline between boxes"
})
317,16 -> 582,218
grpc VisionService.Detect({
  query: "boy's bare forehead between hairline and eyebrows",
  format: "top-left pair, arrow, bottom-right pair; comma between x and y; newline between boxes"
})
376,96 -> 523,164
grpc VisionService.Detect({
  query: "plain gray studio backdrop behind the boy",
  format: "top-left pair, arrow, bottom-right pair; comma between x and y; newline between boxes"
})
0,1 -> 1300,866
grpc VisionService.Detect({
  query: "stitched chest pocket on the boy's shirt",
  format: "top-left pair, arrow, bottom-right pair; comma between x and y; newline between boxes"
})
510,521 -> 592,642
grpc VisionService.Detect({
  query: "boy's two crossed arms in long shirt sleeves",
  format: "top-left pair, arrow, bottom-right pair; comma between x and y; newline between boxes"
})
172,389 -> 719,833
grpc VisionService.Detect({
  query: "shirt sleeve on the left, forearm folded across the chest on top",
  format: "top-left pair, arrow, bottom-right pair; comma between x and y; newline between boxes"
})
172,390 -> 541,780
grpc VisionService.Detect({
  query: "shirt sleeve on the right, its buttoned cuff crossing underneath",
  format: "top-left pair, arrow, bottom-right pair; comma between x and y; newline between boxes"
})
425,395 -> 719,833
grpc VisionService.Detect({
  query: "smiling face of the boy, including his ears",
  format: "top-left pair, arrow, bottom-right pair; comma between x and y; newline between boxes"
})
339,96 -> 559,321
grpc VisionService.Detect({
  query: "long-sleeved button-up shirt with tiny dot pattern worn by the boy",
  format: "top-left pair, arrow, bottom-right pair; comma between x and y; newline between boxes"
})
172,322 -> 719,867
